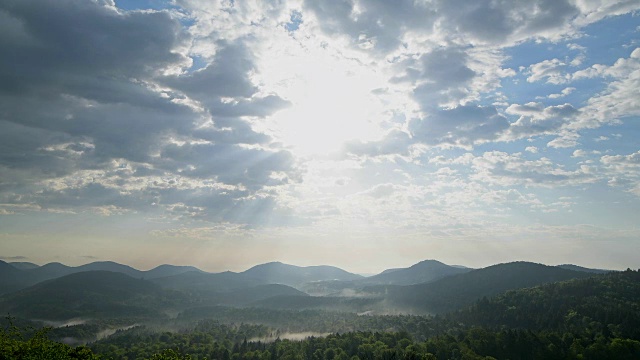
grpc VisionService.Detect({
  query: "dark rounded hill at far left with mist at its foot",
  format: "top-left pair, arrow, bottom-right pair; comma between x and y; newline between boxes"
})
0,271 -> 171,320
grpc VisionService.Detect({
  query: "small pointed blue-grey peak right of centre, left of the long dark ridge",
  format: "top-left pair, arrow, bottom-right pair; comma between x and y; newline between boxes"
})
358,260 -> 471,285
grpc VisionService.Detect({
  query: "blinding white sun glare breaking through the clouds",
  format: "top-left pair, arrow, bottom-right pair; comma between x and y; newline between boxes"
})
258,39 -> 384,156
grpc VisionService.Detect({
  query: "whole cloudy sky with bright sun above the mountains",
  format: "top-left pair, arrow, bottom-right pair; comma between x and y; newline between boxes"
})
0,0 -> 640,273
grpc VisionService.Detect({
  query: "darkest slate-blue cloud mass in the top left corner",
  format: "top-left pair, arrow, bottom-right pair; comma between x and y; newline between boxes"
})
0,0 -> 187,98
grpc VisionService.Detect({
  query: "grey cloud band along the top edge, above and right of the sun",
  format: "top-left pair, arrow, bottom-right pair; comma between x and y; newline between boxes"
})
305,0 -> 579,53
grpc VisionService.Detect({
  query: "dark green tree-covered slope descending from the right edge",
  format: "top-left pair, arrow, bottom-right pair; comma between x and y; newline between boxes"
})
450,270 -> 640,340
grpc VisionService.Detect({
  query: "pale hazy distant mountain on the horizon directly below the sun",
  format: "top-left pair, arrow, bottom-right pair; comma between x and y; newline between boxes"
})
241,262 -> 363,287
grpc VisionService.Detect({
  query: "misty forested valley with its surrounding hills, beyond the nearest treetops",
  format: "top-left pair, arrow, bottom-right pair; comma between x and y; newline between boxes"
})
0,260 -> 640,359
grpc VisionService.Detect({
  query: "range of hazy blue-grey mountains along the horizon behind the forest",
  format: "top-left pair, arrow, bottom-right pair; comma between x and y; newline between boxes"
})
0,260 -> 612,320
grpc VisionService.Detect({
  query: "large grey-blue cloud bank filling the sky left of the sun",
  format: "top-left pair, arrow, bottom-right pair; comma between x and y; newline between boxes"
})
0,0 -> 298,225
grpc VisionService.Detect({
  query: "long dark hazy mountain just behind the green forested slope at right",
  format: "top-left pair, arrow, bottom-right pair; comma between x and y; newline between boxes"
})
380,262 -> 593,314
